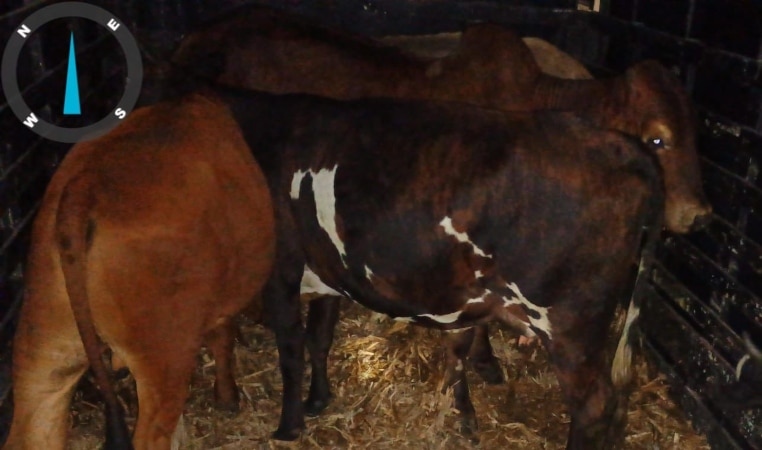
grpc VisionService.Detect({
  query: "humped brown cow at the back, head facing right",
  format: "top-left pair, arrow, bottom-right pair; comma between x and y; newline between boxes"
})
173,8 -> 711,233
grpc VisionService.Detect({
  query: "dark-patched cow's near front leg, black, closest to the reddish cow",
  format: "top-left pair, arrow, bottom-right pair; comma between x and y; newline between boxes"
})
263,275 -> 304,441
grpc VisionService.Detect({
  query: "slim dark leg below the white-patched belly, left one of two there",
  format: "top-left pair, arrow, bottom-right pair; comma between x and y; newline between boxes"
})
443,328 -> 478,435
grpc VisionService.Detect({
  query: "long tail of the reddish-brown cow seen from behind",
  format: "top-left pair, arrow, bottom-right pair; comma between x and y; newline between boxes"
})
56,178 -> 133,450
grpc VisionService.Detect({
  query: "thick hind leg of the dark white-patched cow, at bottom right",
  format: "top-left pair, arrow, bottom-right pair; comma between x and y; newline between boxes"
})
546,330 -> 627,450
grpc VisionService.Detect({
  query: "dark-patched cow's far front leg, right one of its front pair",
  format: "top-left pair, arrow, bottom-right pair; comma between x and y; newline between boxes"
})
304,296 -> 341,416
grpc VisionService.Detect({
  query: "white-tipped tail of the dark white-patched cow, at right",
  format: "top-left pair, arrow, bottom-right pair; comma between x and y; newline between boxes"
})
611,158 -> 664,389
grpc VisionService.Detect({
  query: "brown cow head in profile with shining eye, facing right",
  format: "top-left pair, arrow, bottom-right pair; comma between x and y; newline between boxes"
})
626,61 -> 712,233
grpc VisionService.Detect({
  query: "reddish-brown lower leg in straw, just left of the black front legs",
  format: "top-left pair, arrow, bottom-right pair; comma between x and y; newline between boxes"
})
205,320 -> 240,412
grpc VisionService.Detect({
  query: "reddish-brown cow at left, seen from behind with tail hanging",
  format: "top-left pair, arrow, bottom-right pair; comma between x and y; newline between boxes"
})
5,94 -> 275,450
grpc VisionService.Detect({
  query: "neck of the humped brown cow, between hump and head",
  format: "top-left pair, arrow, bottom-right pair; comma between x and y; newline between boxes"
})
533,75 -> 628,135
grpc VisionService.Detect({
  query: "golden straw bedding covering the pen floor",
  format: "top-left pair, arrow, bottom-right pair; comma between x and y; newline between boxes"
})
72,302 -> 709,450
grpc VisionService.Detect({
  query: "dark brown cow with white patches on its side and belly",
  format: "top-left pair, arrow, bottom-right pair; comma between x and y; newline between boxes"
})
217,87 -> 663,450
